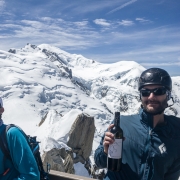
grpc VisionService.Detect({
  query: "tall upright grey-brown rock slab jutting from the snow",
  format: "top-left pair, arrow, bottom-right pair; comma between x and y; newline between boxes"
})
67,113 -> 95,164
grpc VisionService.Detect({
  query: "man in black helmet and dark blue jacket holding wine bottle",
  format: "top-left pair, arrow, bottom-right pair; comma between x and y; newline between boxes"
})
94,68 -> 180,180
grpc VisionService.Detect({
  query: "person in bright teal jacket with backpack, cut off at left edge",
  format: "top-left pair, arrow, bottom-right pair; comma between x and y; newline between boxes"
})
0,120 -> 40,180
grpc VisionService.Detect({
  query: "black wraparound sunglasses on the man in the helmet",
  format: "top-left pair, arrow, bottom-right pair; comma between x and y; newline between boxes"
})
140,87 -> 167,97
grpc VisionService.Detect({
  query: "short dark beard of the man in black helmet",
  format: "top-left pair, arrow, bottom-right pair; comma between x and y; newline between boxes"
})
142,99 -> 168,115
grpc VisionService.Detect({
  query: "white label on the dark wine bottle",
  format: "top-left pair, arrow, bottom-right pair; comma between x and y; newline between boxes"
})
108,139 -> 122,159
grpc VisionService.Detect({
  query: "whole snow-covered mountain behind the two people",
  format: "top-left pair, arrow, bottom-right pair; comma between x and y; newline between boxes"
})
0,44 -> 180,177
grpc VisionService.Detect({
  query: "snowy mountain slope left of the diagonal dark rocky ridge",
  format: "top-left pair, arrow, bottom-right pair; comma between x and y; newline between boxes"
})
0,45 -> 111,133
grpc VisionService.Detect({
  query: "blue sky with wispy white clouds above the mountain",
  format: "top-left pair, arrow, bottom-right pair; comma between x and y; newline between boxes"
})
0,0 -> 180,76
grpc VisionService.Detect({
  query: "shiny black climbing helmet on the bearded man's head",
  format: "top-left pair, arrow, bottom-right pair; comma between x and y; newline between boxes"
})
138,68 -> 172,91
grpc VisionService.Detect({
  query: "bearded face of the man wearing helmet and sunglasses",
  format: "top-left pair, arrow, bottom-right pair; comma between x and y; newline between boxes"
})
140,85 -> 167,114
